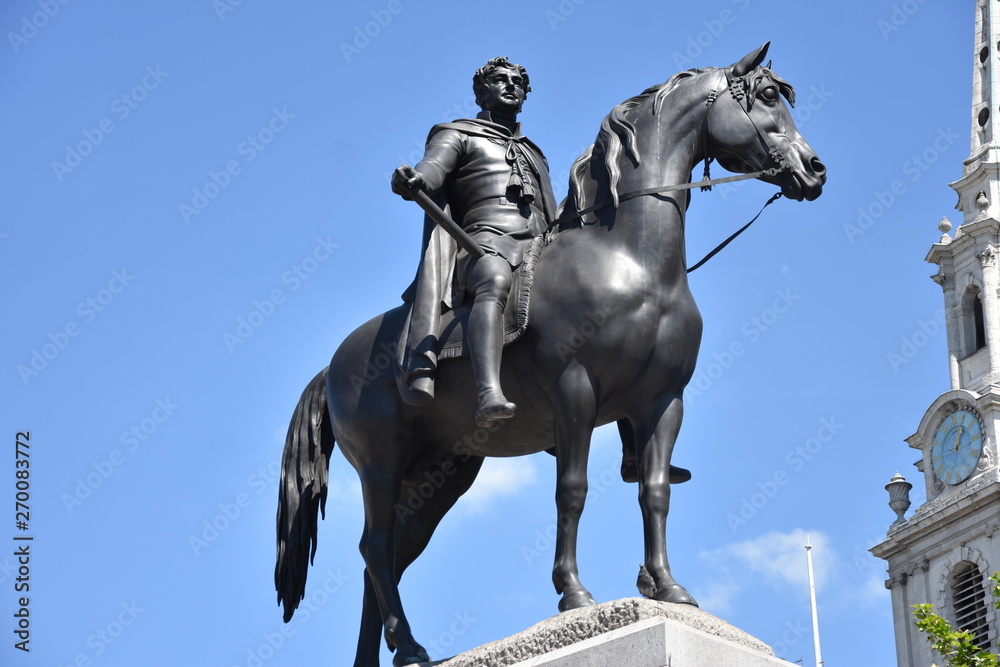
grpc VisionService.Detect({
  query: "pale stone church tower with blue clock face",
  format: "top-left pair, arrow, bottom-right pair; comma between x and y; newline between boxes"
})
871,0 -> 1000,667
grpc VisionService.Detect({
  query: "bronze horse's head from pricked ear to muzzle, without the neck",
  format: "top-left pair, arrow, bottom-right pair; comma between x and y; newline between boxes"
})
706,42 -> 826,201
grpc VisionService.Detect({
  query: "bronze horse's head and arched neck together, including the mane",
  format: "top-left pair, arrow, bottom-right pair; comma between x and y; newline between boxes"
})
561,42 -> 826,226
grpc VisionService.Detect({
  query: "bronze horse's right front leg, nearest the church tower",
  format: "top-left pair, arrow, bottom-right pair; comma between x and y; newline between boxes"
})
635,395 -> 698,607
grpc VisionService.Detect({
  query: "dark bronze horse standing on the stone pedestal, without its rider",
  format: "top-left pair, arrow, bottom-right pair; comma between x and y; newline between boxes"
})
275,44 -> 826,667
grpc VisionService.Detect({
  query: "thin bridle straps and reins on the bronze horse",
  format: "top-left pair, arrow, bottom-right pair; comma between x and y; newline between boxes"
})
549,68 -> 792,273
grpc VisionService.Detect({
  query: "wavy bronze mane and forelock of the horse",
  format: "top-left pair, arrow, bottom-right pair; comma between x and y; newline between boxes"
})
567,63 -> 795,217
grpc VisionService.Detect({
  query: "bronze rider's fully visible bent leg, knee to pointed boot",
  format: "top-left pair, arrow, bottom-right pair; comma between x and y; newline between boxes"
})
465,254 -> 517,426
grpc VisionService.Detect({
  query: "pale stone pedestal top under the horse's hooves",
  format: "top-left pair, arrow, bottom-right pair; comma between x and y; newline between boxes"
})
423,598 -> 791,667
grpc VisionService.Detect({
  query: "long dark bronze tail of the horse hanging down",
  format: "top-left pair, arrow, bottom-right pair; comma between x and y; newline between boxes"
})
274,368 -> 334,623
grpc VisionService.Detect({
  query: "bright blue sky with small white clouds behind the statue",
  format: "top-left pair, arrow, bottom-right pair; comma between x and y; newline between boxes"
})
0,0 -> 974,667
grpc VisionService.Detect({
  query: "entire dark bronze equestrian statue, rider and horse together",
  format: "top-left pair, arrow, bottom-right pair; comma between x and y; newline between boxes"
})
275,44 -> 826,667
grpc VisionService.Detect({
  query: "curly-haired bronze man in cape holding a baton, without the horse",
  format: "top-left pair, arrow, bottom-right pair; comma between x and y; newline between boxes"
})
392,58 -> 556,427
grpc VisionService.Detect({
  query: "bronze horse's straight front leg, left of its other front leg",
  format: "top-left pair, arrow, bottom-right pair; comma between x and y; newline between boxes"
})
552,365 -> 597,611
